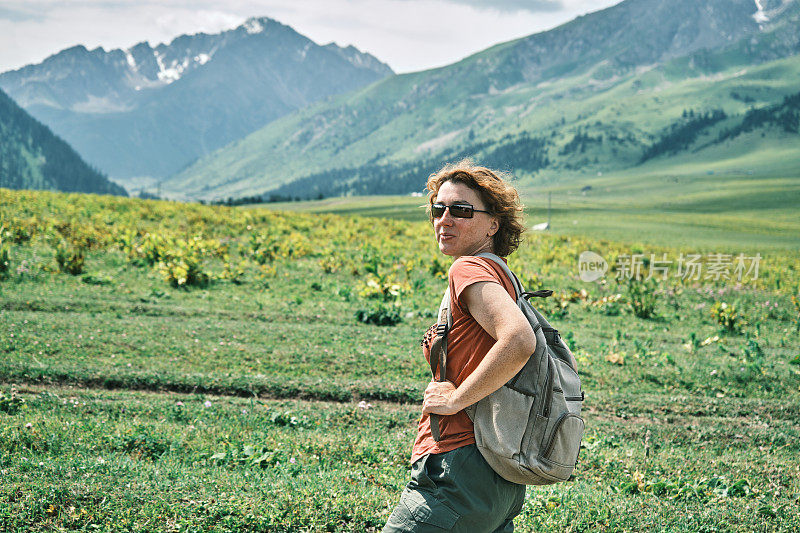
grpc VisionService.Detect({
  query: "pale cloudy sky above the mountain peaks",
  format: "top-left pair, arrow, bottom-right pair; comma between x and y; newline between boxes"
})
0,0 -> 620,72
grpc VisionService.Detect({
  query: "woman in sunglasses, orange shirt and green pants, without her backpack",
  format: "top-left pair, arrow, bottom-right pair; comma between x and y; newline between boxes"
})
383,160 -> 536,533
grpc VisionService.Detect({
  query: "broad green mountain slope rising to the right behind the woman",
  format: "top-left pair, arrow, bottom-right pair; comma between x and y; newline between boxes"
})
163,0 -> 800,200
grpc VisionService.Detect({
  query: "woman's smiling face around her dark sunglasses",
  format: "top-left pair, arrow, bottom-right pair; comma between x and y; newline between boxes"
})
433,181 -> 500,258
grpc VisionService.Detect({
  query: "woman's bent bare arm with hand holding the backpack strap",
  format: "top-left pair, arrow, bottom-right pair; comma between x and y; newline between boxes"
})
422,281 -> 536,415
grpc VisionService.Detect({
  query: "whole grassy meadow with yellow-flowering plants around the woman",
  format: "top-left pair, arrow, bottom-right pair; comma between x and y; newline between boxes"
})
0,186 -> 800,532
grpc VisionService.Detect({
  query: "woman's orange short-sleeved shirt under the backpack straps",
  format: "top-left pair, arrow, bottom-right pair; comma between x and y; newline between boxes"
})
411,256 -> 514,463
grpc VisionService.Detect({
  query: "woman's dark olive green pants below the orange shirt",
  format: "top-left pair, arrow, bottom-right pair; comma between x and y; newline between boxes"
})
383,444 -> 525,533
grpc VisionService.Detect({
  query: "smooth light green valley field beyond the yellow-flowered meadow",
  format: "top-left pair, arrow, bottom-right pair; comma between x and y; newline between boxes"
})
264,145 -> 800,253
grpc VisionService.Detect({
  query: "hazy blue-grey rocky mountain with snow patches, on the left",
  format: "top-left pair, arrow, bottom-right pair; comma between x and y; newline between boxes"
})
0,18 -> 392,183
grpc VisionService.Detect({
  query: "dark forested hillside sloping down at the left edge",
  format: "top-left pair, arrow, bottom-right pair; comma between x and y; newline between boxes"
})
0,91 -> 127,196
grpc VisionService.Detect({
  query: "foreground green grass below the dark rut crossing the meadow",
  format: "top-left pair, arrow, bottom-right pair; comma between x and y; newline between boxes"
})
0,387 -> 800,531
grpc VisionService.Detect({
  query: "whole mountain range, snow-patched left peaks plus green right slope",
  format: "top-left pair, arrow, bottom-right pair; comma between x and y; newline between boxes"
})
0,0 -> 800,201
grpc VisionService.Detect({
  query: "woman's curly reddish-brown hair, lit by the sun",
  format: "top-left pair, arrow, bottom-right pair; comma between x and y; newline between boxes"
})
425,159 -> 525,257
